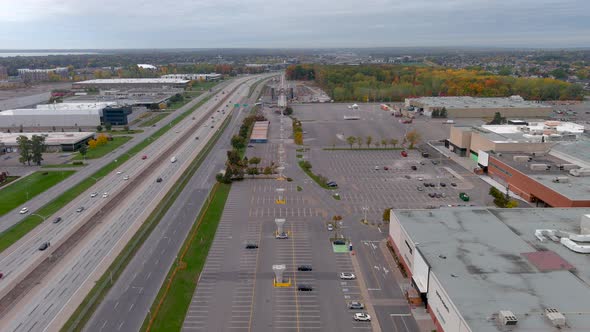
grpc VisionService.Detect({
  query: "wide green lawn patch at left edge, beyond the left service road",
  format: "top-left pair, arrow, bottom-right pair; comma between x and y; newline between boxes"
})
0,171 -> 75,218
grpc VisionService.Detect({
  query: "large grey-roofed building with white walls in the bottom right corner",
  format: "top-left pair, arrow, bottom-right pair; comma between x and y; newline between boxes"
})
388,207 -> 590,332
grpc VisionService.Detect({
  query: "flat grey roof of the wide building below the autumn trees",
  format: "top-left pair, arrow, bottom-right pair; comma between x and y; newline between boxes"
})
409,96 -> 551,109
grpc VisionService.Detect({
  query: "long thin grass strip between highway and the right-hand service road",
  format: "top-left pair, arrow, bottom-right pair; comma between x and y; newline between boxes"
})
60,104 -> 231,331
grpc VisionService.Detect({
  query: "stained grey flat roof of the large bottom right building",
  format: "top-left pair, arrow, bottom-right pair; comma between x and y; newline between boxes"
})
394,208 -> 590,332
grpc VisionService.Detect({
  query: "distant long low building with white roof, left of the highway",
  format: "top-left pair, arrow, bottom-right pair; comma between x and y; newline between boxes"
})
72,78 -> 190,90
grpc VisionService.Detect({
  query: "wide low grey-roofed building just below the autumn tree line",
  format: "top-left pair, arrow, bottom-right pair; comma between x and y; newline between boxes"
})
405,96 -> 552,119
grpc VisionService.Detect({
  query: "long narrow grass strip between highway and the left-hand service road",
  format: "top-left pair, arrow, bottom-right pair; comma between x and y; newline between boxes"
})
0,92 -> 212,252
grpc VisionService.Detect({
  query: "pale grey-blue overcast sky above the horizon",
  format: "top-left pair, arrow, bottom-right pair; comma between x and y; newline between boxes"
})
0,0 -> 590,49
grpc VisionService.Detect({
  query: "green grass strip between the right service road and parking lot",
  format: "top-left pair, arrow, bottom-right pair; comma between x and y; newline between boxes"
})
141,183 -> 231,331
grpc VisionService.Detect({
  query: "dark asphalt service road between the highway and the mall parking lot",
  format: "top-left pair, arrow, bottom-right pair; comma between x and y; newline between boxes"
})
85,75 -> 272,331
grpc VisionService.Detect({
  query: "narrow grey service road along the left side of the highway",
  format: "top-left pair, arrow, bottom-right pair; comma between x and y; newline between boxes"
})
0,82 -> 229,232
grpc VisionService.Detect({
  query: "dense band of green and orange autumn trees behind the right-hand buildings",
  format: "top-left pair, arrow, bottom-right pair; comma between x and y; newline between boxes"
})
286,64 -> 583,102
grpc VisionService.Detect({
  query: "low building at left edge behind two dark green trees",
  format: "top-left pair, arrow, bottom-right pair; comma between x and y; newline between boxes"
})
0,132 -> 94,152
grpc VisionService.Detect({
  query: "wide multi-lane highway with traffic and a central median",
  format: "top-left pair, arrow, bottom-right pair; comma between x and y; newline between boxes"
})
0,77 -> 260,331
